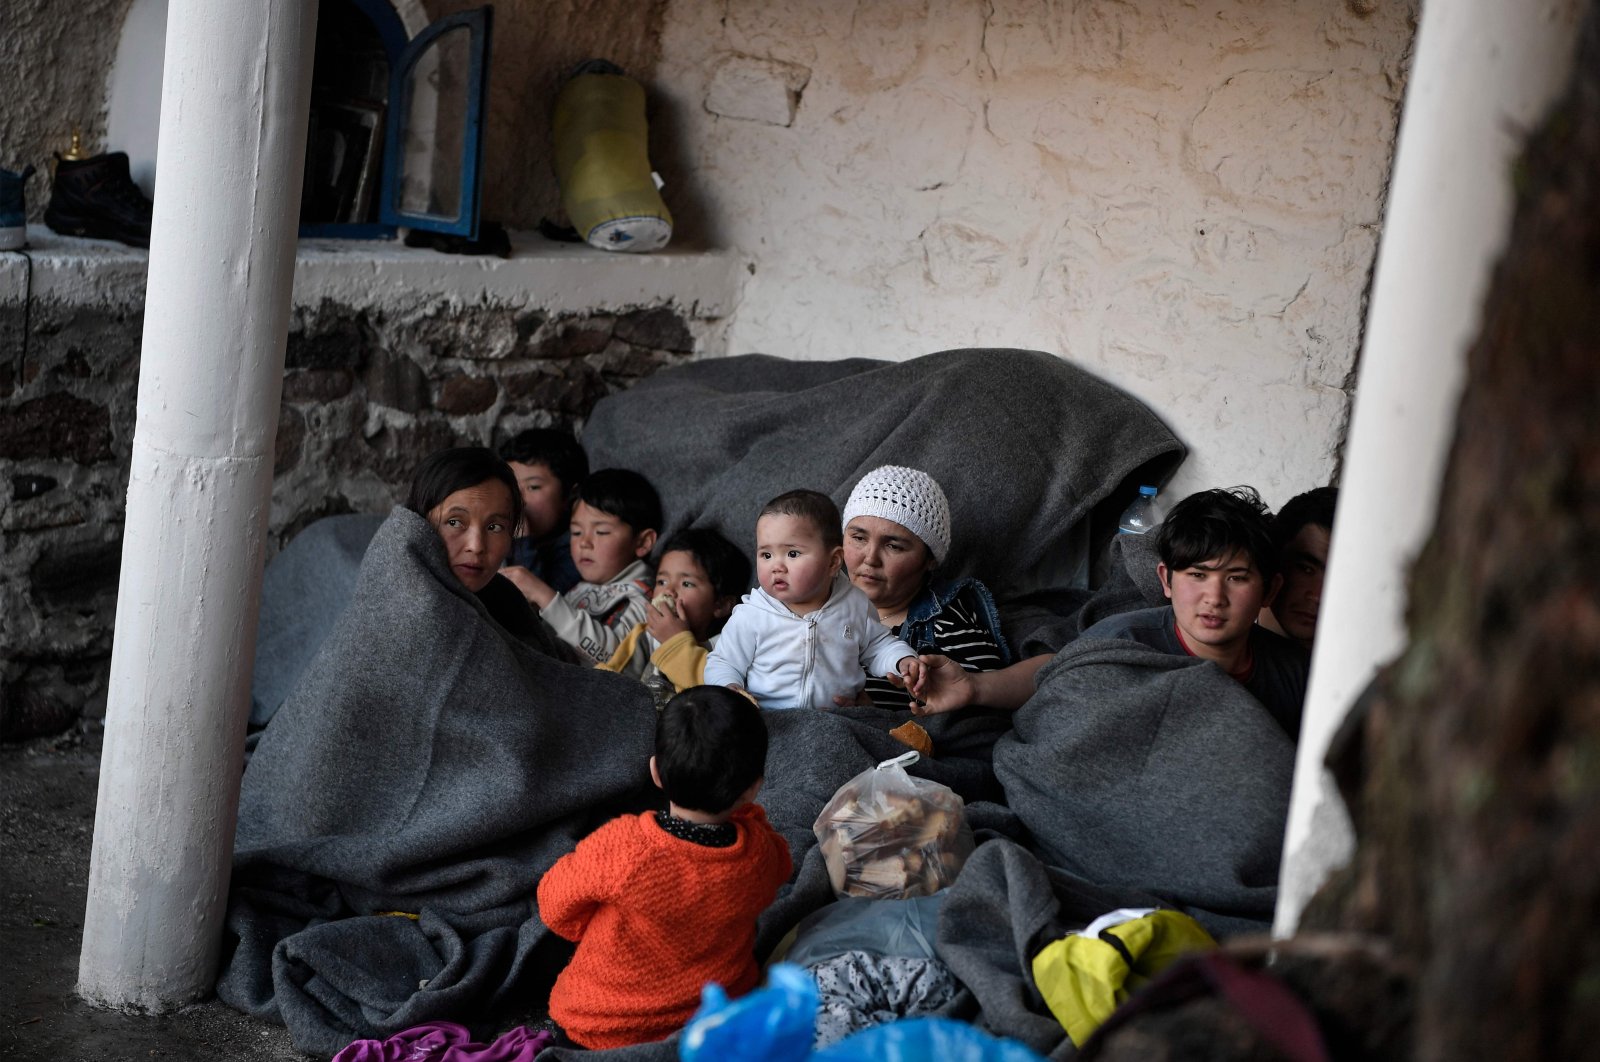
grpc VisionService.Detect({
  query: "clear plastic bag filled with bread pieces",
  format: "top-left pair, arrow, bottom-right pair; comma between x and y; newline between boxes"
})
811,752 -> 973,899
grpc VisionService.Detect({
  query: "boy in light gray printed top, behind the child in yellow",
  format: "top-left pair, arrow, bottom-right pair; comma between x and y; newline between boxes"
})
507,469 -> 661,664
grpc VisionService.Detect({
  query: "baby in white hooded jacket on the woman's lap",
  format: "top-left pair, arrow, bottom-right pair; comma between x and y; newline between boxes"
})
706,491 -> 922,709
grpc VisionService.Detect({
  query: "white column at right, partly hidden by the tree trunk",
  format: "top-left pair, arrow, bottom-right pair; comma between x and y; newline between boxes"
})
1274,0 -> 1586,936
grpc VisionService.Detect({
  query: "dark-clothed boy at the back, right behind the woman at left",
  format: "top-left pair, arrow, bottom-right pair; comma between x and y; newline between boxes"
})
499,427 -> 589,593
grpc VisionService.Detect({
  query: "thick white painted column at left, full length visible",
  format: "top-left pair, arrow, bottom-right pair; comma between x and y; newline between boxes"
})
78,0 -> 317,1011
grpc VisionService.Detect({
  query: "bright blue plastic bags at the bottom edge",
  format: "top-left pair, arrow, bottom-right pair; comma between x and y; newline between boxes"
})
678,963 -> 1045,1062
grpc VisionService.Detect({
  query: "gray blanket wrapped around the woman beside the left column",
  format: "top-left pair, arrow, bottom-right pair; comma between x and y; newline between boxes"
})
218,509 -> 656,1052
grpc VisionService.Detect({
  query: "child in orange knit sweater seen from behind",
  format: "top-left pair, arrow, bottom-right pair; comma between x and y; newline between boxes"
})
538,686 -> 794,1048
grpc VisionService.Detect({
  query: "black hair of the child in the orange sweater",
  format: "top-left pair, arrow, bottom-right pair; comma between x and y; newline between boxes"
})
656,686 -> 766,814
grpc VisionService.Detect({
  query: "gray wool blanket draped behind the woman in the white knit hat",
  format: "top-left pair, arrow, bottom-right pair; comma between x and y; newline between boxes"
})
584,349 -> 1184,597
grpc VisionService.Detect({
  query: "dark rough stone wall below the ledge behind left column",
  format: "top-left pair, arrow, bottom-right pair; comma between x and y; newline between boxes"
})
0,281 -> 709,739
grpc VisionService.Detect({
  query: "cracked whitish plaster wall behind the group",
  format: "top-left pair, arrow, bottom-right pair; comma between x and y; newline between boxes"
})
653,0 -> 1416,504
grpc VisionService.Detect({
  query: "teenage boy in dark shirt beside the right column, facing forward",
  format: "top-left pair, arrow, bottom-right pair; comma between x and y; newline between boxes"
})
1080,486 -> 1310,737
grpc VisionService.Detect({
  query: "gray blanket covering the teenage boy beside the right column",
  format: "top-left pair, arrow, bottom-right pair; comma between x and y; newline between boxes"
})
994,638 -> 1294,936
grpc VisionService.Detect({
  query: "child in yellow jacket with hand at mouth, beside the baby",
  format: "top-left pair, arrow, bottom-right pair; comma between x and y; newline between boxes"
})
598,528 -> 750,693
